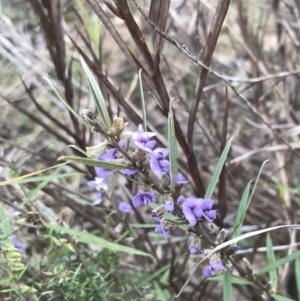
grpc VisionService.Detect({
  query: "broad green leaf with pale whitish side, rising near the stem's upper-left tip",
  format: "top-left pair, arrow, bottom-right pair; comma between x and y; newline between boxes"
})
80,57 -> 112,131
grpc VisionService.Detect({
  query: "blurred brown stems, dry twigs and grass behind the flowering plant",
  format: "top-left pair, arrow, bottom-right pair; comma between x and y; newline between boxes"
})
0,0 -> 300,300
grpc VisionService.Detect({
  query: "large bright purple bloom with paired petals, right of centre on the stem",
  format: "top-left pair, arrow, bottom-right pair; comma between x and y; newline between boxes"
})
182,197 -> 217,226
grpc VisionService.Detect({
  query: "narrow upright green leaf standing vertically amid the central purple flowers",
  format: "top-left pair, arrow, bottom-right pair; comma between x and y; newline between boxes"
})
168,100 -> 178,191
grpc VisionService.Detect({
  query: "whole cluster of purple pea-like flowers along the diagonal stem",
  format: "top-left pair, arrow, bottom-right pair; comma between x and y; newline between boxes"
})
89,121 -> 239,277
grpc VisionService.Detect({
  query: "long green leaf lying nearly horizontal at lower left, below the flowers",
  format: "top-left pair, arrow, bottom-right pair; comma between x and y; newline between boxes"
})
46,224 -> 151,256
